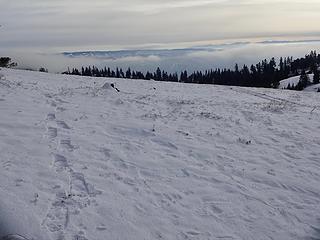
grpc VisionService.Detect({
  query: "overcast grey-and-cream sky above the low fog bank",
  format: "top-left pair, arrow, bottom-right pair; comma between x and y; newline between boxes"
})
0,0 -> 320,71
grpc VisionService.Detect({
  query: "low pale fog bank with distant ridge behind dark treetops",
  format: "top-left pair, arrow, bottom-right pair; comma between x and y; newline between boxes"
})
3,40 -> 320,75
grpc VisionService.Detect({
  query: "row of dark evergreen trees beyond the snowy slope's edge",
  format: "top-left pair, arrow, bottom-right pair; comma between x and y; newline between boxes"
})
64,51 -> 320,88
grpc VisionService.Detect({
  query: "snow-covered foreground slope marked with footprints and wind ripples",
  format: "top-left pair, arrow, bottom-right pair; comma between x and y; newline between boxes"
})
0,69 -> 320,240
